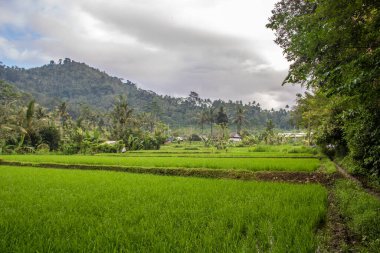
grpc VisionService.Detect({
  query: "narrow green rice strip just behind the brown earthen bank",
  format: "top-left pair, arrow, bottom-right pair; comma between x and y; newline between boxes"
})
0,155 -> 320,172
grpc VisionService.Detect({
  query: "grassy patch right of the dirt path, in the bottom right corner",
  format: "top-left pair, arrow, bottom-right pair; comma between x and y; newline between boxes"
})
334,180 -> 380,252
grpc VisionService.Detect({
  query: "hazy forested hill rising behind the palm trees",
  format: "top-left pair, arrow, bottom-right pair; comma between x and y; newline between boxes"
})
0,58 -> 291,129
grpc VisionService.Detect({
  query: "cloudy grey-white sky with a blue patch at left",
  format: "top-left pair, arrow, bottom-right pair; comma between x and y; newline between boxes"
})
0,0 -> 301,109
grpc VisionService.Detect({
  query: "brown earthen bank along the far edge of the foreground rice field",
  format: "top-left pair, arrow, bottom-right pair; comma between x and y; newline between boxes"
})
0,160 -> 339,185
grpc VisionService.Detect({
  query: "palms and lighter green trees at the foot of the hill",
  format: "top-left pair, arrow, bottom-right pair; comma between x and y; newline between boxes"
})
0,80 -> 290,154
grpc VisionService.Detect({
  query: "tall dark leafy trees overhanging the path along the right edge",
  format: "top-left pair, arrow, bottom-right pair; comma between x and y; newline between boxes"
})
267,0 -> 380,176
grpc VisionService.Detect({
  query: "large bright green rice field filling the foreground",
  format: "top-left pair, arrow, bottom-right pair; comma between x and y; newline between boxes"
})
0,166 -> 327,252
